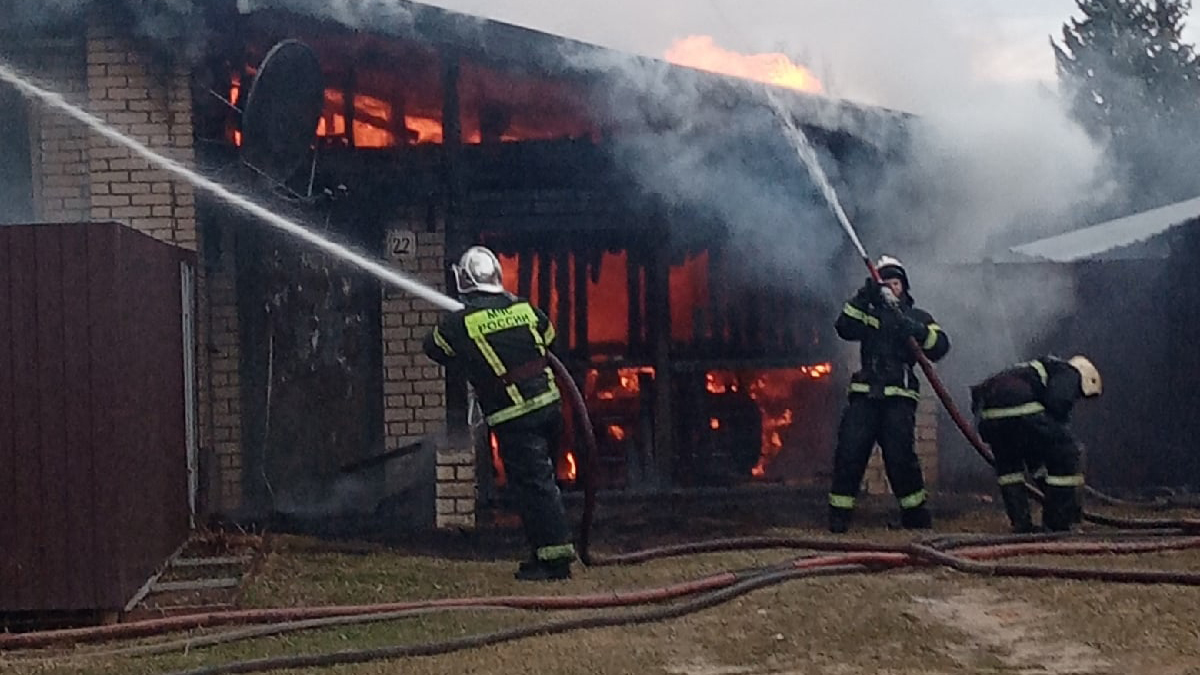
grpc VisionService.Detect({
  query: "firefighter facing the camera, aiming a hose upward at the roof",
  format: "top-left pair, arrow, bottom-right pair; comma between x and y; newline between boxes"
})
829,256 -> 950,533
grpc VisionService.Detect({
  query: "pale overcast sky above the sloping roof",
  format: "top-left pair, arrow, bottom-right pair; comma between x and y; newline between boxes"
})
427,0 -> 1200,106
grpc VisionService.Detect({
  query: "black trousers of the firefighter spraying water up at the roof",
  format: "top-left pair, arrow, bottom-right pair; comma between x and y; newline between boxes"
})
829,394 -> 925,512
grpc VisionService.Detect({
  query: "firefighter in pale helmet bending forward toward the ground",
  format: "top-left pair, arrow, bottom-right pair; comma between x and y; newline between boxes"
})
971,356 -> 1102,532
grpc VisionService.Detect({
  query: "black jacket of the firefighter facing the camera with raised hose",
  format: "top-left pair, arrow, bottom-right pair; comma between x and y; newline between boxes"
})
834,289 -> 950,400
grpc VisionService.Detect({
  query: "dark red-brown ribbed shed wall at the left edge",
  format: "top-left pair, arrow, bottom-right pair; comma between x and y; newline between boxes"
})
0,222 -> 194,614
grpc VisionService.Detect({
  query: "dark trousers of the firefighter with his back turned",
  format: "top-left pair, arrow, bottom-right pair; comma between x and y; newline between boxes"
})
492,406 -> 574,561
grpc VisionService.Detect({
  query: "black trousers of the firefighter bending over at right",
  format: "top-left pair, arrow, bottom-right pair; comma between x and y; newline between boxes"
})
979,413 -> 1081,531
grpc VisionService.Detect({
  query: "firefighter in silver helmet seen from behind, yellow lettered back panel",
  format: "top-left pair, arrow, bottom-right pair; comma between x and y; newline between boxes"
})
425,246 -> 575,581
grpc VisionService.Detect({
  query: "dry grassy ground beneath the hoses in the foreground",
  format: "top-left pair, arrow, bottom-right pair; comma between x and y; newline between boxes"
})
0,494 -> 1200,675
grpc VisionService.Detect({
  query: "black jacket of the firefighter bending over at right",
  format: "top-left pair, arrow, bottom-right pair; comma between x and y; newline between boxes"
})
971,356 -> 1084,424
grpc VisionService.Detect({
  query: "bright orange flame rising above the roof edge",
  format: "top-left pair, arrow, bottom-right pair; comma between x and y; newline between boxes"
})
664,35 -> 824,94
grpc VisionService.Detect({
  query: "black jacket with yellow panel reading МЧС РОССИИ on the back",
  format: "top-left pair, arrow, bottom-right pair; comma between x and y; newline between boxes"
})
424,293 -> 560,426
